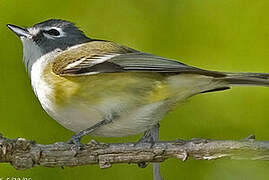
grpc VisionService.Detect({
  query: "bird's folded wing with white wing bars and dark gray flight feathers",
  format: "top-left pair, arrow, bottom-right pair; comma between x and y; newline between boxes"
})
53,41 -> 225,77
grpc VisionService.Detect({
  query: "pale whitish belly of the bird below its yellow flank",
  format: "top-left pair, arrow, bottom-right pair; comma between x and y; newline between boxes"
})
44,99 -> 166,137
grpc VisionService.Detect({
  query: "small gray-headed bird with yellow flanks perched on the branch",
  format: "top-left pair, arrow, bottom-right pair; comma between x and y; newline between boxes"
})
7,19 -> 269,145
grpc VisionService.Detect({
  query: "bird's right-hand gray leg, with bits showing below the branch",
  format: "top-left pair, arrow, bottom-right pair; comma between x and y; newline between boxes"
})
138,123 -> 163,180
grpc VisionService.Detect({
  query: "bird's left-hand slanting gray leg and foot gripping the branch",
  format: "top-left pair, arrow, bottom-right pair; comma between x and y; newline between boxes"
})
67,119 -> 112,146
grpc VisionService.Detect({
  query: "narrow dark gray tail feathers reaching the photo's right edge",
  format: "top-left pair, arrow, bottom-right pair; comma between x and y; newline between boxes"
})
219,73 -> 269,86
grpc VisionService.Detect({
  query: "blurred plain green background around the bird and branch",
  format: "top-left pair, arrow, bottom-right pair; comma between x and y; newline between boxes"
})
0,0 -> 269,180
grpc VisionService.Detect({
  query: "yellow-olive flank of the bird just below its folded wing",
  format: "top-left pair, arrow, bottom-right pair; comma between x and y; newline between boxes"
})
43,64 -> 170,107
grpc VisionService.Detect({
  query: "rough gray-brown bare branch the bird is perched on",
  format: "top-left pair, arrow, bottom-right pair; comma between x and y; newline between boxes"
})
0,136 -> 269,170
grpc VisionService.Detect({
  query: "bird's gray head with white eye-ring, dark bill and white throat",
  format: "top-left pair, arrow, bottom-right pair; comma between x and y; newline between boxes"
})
7,19 -> 90,72
